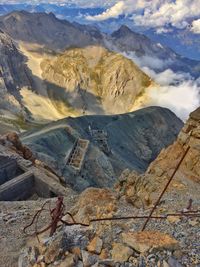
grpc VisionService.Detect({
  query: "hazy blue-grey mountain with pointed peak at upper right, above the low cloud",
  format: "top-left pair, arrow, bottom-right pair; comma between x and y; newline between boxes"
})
110,25 -> 200,77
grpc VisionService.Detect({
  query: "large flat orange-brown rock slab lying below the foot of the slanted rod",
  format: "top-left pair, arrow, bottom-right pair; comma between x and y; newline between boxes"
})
122,231 -> 178,253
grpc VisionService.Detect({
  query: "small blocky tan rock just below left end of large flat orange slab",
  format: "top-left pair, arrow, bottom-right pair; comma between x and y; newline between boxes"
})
111,243 -> 133,262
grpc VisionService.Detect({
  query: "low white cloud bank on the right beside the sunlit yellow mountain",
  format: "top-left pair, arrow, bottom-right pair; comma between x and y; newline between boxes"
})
123,49 -> 200,121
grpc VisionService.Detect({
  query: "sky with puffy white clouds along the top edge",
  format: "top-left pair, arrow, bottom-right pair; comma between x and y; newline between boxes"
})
3,0 -> 200,34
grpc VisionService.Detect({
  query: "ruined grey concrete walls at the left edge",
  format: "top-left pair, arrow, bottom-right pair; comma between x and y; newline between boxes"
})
0,156 -> 73,201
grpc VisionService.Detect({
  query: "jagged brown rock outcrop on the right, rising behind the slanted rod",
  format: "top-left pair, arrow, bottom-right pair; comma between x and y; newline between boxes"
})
116,108 -> 200,207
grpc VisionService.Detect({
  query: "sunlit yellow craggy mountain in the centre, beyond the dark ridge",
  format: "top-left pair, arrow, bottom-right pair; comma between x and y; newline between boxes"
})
41,46 -> 151,114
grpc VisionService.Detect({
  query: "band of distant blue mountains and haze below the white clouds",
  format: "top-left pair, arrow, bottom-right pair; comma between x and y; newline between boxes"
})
0,1 -> 200,60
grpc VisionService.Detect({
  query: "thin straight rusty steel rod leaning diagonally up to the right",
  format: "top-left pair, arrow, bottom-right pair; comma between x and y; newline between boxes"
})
142,146 -> 190,231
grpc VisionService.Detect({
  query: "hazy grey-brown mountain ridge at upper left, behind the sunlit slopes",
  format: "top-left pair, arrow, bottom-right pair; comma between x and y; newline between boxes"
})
0,11 -> 101,50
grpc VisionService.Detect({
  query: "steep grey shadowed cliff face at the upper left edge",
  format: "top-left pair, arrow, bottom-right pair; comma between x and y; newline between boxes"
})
0,30 -> 31,116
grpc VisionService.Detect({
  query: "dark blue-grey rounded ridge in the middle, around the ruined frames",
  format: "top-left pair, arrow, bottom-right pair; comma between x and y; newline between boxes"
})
21,107 -> 183,191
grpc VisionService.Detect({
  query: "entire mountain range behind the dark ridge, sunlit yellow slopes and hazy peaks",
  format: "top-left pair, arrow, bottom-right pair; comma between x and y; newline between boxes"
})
0,11 -> 200,131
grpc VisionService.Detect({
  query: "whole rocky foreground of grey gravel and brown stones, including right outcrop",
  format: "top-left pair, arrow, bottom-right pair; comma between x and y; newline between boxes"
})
0,109 -> 200,267
